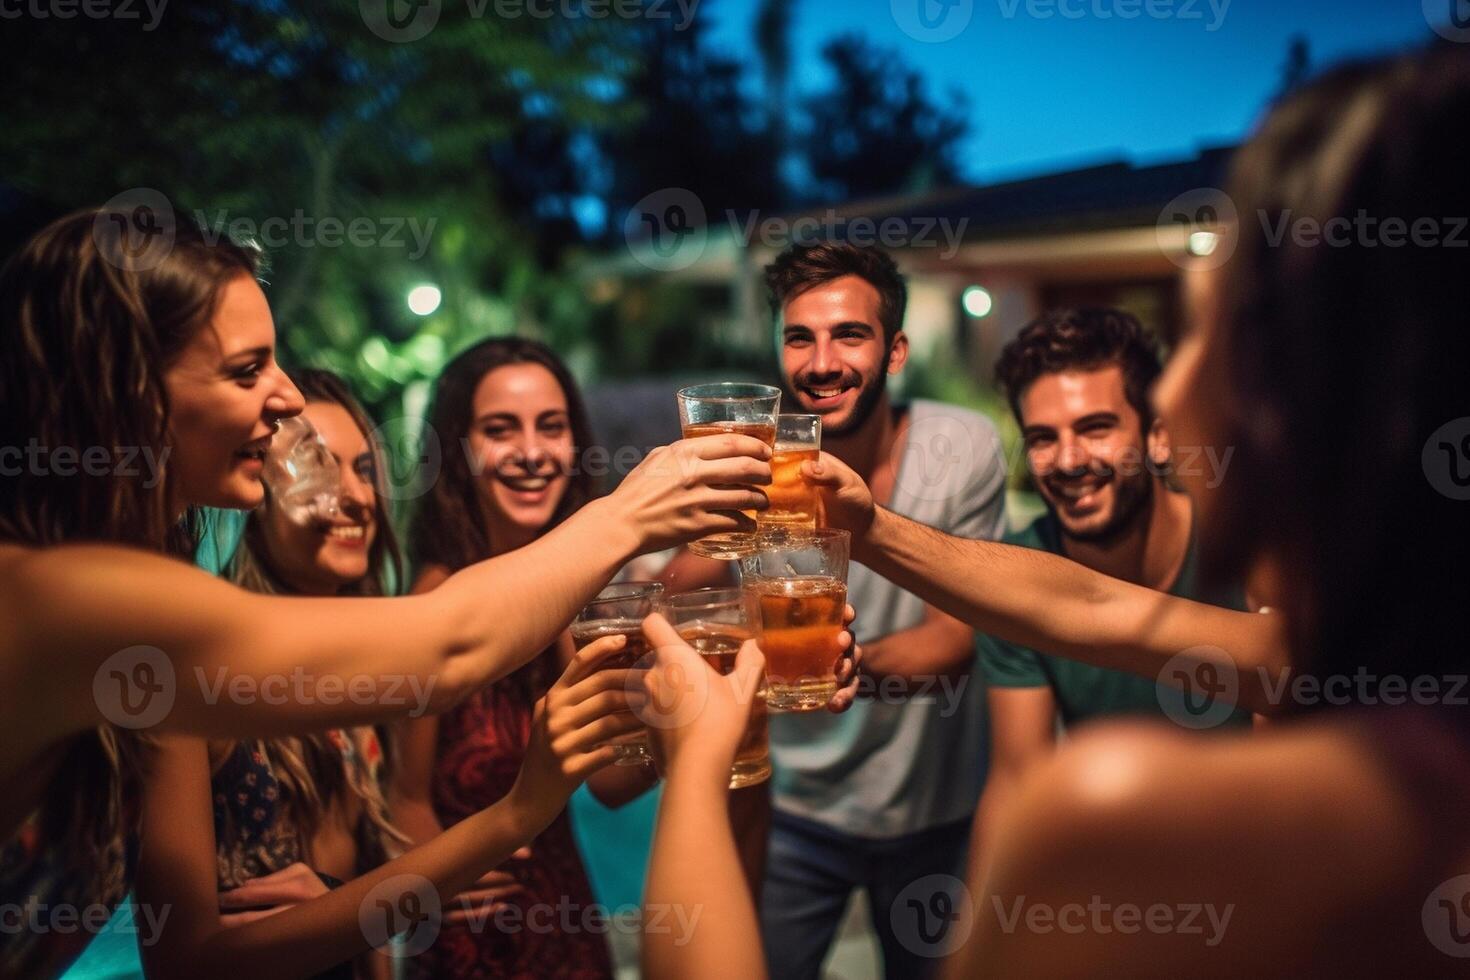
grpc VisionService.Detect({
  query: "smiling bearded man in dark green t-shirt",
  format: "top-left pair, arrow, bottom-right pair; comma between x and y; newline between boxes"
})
975,309 -> 1250,855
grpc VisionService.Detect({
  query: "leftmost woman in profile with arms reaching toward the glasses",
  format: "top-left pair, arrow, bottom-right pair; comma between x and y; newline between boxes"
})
0,212 -> 770,976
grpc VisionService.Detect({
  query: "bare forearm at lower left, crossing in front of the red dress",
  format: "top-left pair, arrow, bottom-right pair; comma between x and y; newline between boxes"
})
170,795 -> 554,977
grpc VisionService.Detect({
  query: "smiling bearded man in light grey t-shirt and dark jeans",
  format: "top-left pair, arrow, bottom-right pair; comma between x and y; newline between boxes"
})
761,242 -> 1005,979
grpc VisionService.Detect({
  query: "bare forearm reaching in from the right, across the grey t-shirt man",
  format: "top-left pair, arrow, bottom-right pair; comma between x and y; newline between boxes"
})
854,508 -> 1286,713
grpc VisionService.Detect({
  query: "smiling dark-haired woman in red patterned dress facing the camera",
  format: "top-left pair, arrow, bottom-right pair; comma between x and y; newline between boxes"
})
391,336 -> 626,979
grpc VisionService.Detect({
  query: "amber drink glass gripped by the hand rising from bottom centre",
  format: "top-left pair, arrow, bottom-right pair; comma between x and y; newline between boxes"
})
659,589 -> 770,789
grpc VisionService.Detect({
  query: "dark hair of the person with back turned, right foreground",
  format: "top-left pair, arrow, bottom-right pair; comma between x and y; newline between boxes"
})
1202,44 -> 1470,690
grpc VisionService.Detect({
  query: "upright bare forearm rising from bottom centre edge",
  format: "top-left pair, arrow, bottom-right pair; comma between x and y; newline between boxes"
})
642,760 -> 766,980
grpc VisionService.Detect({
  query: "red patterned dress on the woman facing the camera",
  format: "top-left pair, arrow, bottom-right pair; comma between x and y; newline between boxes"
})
407,652 -> 613,980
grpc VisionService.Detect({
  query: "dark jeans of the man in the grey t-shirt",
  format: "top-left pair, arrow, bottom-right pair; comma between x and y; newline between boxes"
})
760,810 -> 970,980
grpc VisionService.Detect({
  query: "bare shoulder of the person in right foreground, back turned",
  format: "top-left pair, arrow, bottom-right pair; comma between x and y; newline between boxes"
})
1016,723 -> 1413,895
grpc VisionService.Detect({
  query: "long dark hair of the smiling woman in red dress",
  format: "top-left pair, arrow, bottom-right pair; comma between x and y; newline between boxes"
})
409,336 -> 598,699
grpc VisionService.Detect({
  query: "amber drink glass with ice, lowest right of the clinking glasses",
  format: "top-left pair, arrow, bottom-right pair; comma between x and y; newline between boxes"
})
739,529 -> 851,711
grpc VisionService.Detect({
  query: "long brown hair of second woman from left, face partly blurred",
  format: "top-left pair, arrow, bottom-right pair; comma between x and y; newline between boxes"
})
223,369 -> 409,862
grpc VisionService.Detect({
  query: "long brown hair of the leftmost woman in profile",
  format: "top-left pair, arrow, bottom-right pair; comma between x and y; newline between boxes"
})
0,209 -> 257,922
